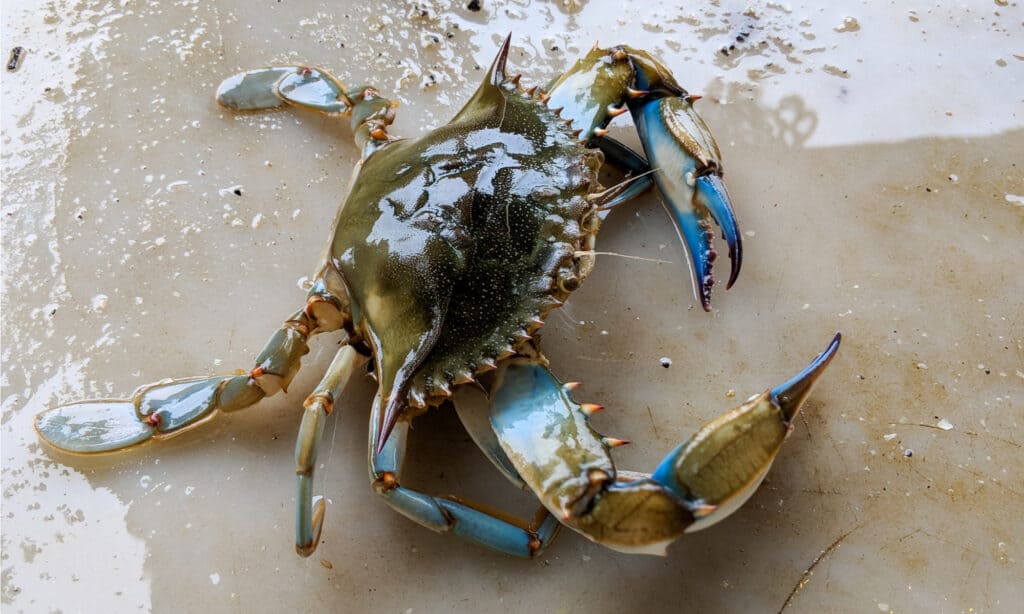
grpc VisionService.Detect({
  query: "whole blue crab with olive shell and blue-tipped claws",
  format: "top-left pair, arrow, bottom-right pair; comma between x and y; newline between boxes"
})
36,39 -> 840,557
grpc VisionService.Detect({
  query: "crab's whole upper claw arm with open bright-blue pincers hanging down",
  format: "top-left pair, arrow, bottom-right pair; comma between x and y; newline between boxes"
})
541,46 -> 742,311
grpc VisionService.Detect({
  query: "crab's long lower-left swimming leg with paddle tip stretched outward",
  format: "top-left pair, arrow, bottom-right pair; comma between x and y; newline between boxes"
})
35,284 -> 347,454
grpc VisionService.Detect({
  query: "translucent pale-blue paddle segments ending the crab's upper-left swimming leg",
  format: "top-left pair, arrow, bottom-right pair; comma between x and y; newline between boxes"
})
216,67 -> 352,115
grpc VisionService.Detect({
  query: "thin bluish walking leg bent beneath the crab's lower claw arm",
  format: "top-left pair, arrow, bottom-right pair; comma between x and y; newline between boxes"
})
370,393 -> 561,559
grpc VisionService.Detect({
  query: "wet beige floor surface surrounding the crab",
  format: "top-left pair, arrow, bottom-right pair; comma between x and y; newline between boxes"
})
0,0 -> 1024,612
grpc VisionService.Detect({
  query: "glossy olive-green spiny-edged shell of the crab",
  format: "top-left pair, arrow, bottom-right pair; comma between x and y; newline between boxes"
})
331,57 -> 602,410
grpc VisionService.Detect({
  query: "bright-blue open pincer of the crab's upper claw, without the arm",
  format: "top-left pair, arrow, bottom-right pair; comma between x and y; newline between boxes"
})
630,95 -> 743,311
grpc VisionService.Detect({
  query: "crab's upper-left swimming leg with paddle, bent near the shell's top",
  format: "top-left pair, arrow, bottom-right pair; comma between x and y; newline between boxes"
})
216,65 -> 398,158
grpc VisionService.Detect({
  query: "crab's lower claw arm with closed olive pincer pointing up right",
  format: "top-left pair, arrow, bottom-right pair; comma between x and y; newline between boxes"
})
490,335 -> 840,555
